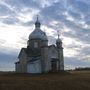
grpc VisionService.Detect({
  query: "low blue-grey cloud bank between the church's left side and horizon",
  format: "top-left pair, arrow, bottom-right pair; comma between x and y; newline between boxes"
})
0,52 -> 18,71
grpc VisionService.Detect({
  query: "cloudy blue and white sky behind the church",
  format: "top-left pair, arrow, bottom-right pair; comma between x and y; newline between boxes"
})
0,0 -> 90,71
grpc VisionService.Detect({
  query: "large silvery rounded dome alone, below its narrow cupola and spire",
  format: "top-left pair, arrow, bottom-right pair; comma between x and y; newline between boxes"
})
29,28 -> 48,40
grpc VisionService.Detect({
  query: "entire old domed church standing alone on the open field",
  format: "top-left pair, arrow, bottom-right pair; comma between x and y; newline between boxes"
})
15,18 -> 64,73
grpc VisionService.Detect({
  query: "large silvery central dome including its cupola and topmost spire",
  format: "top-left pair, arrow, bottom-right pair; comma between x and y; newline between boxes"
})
29,17 -> 48,40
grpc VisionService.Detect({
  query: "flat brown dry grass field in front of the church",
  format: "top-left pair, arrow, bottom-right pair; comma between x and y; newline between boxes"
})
0,71 -> 90,90
